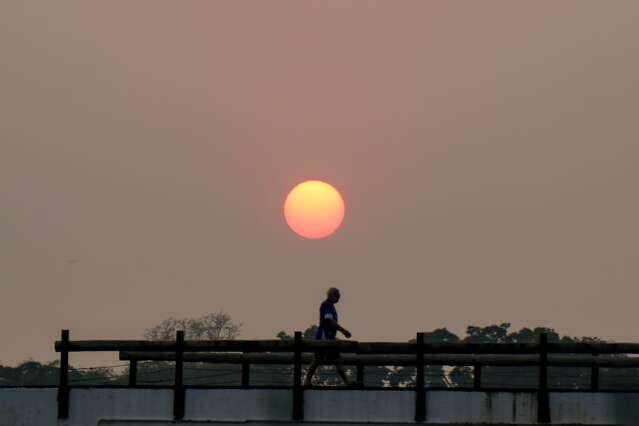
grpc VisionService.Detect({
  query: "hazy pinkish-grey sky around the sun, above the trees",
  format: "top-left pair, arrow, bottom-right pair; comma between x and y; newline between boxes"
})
0,0 -> 639,364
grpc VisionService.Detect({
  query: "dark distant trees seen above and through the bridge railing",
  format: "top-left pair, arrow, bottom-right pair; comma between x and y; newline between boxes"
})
0,311 -> 639,388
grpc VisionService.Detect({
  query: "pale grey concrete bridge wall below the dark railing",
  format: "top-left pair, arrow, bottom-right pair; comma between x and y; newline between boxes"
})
0,388 -> 639,426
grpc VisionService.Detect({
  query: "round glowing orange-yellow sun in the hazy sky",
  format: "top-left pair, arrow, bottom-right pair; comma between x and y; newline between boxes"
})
284,180 -> 344,240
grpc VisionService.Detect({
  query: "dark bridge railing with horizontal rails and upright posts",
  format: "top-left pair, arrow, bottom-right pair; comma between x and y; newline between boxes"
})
55,330 -> 639,423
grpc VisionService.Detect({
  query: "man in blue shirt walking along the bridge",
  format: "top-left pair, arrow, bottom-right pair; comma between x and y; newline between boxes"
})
304,287 -> 355,386
